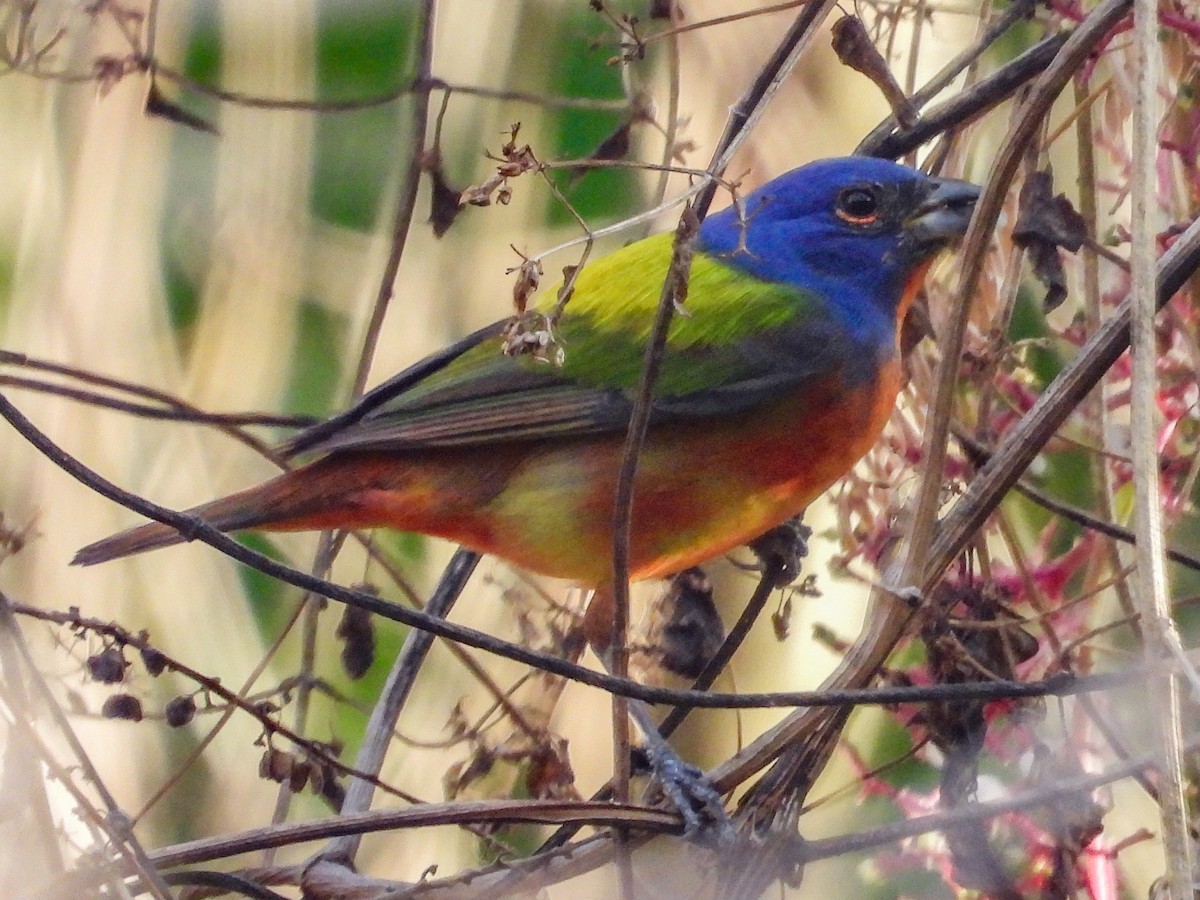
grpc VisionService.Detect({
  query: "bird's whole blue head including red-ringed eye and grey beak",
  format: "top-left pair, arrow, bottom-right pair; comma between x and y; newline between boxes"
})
700,156 -> 979,338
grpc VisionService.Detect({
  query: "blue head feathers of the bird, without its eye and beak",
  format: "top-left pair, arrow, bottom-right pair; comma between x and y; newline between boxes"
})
698,157 -> 928,341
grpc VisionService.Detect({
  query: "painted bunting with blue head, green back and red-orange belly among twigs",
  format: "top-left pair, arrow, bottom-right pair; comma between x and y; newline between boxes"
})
74,157 -> 978,600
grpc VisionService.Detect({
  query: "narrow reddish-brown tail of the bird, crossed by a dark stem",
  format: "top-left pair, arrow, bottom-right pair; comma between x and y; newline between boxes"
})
71,473 -> 321,565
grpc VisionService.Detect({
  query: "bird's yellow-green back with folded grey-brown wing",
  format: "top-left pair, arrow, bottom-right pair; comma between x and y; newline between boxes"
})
287,238 -> 852,452
